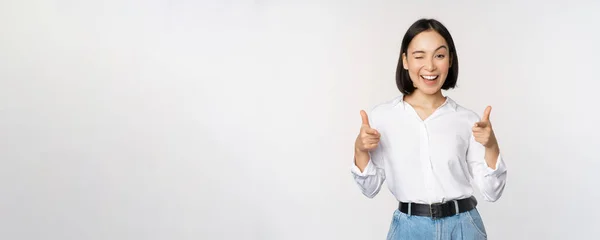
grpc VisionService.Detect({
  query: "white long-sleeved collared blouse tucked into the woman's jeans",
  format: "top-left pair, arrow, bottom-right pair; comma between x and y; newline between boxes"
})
351,95 -> 506,204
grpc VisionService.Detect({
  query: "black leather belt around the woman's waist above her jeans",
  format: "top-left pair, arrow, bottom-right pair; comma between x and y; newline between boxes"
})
398,196 -> 477,218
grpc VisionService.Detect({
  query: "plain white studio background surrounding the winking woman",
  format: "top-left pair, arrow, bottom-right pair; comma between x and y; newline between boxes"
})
0,0 -> 600,240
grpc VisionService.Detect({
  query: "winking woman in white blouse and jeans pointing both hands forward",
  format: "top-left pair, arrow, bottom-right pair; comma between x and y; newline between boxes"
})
352,19 -> 506,239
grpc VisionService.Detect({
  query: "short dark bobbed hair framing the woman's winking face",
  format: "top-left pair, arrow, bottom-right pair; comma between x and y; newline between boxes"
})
396,18 -> 458,95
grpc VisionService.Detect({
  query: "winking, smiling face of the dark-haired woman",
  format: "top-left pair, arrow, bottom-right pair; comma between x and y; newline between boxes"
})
402,30 -> 451,94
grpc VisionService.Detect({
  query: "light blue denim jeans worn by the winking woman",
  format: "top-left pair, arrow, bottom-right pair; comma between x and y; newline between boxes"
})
387,208 -> 487,240
